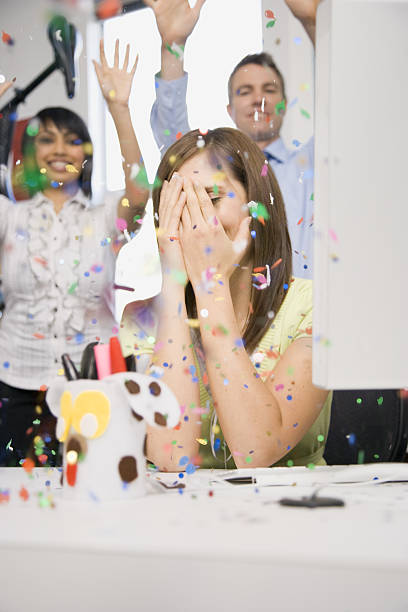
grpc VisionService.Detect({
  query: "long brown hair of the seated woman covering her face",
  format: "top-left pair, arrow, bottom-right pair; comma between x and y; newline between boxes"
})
153,128 -> 292,352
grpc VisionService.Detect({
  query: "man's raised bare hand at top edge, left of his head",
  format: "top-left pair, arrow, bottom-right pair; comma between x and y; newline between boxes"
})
144,0 -> 205,45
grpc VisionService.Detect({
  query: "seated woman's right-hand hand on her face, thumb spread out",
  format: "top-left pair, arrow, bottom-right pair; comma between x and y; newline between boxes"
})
180,179 -> 251,289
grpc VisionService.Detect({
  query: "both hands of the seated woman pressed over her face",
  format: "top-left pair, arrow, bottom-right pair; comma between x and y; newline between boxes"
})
158,175 -> 251,288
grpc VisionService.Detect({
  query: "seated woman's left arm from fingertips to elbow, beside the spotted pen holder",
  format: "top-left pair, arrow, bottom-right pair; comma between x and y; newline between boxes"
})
147,174 -> 201,471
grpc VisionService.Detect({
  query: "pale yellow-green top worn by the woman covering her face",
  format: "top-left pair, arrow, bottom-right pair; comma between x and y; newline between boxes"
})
121,278 -> 332,469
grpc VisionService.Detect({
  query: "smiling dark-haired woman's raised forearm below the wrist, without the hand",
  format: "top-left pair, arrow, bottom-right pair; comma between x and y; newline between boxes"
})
108,102 -> 150,230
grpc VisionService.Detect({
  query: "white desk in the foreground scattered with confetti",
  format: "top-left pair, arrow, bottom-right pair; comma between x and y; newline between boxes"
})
0,466 -> 408,612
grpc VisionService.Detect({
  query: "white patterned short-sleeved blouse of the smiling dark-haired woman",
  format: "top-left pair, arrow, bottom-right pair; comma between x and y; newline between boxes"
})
0,191 -> 119,389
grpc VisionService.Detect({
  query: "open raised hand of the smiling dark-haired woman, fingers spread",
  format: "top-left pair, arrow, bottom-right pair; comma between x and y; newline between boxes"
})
92,39 -> 138,107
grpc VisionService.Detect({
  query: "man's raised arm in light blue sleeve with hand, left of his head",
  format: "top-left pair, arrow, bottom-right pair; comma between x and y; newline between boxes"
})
144,0 -> 205,155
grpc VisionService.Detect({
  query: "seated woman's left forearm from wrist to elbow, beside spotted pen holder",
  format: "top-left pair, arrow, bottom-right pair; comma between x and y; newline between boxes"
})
147,274 -> 201,471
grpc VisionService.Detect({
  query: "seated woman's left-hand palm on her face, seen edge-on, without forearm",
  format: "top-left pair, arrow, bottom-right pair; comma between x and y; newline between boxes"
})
157,173 -> 187,285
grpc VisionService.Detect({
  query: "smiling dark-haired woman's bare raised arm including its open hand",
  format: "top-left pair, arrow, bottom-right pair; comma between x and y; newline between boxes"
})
93,40 -> 150,231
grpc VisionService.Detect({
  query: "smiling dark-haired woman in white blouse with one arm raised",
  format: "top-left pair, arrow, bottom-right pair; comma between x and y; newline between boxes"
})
0,41 -> 149,465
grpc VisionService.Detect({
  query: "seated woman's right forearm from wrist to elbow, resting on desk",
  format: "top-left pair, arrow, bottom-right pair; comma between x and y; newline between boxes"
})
196,286 -> 287,467
